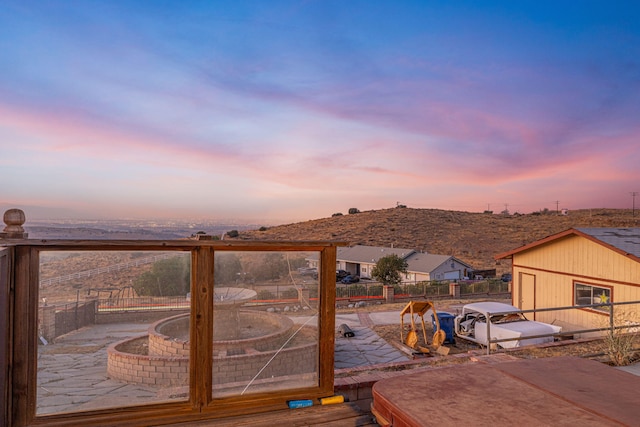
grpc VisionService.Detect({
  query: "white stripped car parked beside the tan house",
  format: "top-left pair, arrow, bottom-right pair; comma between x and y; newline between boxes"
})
453,302 -> 562,348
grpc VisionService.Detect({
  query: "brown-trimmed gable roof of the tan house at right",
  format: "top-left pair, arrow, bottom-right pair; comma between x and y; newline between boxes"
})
495,228 -> 640,262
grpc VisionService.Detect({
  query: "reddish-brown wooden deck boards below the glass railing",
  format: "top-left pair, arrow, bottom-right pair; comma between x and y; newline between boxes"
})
164,402 -> 378,427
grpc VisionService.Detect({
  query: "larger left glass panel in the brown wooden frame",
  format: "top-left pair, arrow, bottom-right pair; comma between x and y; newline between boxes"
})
36,251 -> 191,415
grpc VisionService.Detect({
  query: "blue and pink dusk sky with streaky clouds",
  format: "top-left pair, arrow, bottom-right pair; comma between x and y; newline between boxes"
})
0,0 -> 640,223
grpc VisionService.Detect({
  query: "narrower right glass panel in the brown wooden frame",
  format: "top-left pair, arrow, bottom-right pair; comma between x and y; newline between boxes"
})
212,252 -> 320,398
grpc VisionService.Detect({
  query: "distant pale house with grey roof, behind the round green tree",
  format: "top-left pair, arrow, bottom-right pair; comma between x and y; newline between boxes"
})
307,245 -> 471,282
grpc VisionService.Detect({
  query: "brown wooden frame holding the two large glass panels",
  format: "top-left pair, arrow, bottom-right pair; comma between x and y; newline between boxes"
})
0,240 -> 344,427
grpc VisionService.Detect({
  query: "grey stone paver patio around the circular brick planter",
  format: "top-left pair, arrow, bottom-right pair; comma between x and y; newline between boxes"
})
37,313 -> 409,415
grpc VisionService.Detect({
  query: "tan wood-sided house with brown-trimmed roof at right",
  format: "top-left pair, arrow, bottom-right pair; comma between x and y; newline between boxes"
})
496,228 -> 640,331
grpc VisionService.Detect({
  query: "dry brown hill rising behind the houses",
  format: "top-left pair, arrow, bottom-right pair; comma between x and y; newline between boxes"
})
237,207 -> 640,273
